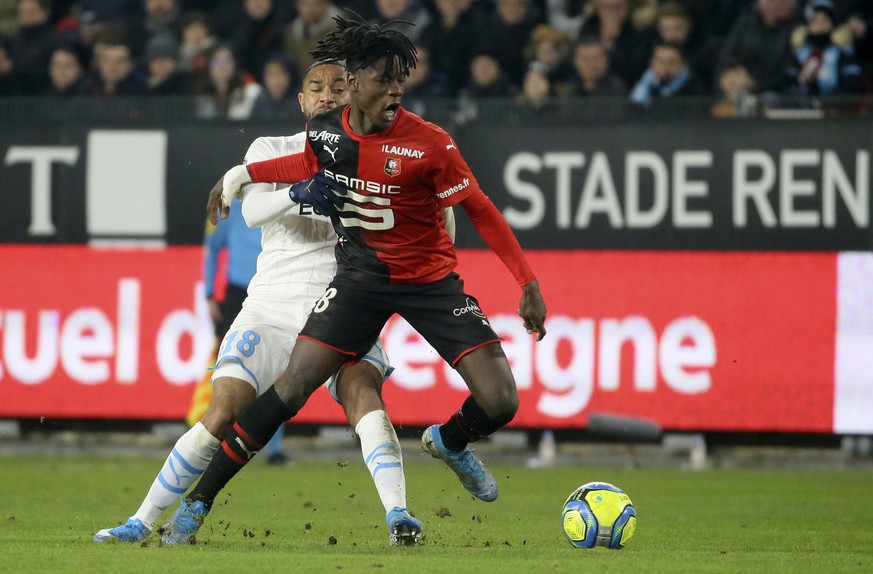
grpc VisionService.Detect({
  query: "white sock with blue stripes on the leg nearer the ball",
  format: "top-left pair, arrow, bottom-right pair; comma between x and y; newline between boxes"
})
355,410 -> 406,514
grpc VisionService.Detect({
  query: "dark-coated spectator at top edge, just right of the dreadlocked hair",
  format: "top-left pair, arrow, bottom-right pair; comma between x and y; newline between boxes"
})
420,0 -> 484,94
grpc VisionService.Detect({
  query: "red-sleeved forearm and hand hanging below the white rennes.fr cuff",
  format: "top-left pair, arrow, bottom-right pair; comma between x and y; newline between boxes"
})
460,189 -> 546,341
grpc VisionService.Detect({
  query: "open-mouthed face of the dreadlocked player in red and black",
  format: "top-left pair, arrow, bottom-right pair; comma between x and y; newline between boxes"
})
349,58 -> 406,134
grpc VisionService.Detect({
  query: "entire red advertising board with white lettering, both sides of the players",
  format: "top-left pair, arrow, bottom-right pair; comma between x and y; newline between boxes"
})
0,246 -> 837,432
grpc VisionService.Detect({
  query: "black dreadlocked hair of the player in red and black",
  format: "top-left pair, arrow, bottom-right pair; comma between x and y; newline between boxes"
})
309,9 -> 418,77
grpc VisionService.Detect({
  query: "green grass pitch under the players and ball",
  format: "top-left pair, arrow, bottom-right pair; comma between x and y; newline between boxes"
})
0,453 -> 873,574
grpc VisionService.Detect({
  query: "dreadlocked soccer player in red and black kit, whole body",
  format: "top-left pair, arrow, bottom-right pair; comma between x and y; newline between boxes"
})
162,11 -> 546,548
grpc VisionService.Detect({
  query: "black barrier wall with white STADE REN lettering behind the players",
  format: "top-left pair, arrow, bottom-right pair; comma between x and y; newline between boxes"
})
0,119 -> 873,251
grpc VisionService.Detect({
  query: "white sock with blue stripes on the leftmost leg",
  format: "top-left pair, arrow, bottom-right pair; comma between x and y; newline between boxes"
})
132,422 -> 221,529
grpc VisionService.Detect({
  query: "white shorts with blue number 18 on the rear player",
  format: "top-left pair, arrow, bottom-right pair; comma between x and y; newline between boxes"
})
211,297 -> 394,402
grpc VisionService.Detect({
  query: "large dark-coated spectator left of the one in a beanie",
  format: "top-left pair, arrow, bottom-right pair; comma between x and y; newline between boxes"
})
716,0 -> 801,93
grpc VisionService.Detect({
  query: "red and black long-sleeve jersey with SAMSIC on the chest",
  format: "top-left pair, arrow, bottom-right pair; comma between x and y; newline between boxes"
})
248,107 -> 534,286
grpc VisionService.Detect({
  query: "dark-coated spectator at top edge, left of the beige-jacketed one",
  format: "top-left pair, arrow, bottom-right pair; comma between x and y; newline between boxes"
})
230,0 -> 283,81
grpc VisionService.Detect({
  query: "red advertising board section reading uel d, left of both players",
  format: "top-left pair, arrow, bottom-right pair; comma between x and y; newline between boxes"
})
0,246 -> 213,419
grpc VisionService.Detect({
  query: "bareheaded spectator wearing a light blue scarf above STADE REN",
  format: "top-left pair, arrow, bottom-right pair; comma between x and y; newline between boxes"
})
630,40 -> 706,107
